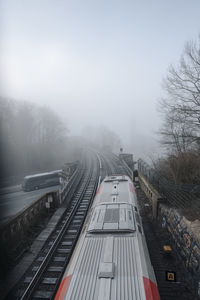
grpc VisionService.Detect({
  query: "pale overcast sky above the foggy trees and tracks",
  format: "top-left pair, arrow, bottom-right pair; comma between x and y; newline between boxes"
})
0,0 -> 200,158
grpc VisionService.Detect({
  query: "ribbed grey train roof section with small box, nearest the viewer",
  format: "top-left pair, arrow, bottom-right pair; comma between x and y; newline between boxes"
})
61,236 -> 148,300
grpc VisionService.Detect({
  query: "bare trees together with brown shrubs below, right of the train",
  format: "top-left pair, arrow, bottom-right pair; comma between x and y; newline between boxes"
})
157,37 -> 200,184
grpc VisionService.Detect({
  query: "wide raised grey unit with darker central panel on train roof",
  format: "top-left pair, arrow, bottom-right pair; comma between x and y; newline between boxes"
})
88,203 -> 135,233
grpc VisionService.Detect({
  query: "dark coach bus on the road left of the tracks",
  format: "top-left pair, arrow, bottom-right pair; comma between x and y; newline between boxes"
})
22,170 -> 62,192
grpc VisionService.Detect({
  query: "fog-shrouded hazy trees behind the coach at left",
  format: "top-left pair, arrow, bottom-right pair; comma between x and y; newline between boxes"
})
0,97 -> 68,178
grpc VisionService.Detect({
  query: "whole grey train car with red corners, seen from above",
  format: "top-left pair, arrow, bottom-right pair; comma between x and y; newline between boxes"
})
55,175 -> 160,300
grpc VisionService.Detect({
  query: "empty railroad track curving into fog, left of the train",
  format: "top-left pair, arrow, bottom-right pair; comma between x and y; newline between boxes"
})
7,154 -> 99,300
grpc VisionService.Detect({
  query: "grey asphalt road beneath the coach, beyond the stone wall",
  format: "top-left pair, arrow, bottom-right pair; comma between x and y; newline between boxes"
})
0,185 -> 59,222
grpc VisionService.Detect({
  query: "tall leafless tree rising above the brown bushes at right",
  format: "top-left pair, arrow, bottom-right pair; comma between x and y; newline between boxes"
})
160,36 -> 200,152
